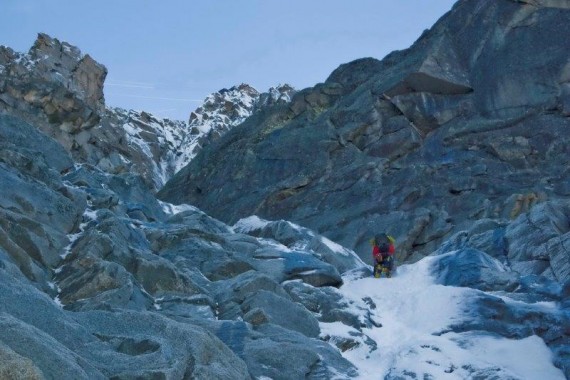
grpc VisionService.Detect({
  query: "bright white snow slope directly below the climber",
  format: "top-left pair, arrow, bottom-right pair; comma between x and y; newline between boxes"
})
328,257 -> 565,380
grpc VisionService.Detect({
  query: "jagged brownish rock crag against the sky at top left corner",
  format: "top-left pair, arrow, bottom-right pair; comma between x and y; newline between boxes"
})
0,34 -> 107,133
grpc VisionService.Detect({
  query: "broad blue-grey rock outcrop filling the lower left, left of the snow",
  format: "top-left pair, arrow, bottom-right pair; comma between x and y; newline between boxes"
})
0,111 -> 363,379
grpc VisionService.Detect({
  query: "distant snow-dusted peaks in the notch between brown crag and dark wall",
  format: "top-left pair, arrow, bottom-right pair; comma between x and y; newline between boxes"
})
108,84 -> 295,189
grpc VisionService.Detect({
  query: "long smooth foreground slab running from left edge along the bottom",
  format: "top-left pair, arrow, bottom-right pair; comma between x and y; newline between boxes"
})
0,273 -> 250,379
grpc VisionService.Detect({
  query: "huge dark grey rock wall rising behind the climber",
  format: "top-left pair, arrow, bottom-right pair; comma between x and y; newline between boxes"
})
159,0 -> 570,281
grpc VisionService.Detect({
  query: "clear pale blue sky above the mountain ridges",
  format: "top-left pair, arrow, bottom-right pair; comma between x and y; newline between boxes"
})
0,0 -> 456,120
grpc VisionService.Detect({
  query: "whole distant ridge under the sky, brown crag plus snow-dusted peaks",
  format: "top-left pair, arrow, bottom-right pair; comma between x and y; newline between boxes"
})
0,34 -> 295,191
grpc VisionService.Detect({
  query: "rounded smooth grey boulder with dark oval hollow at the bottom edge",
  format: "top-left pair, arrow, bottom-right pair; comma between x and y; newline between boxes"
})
75,312 -> 250,379
